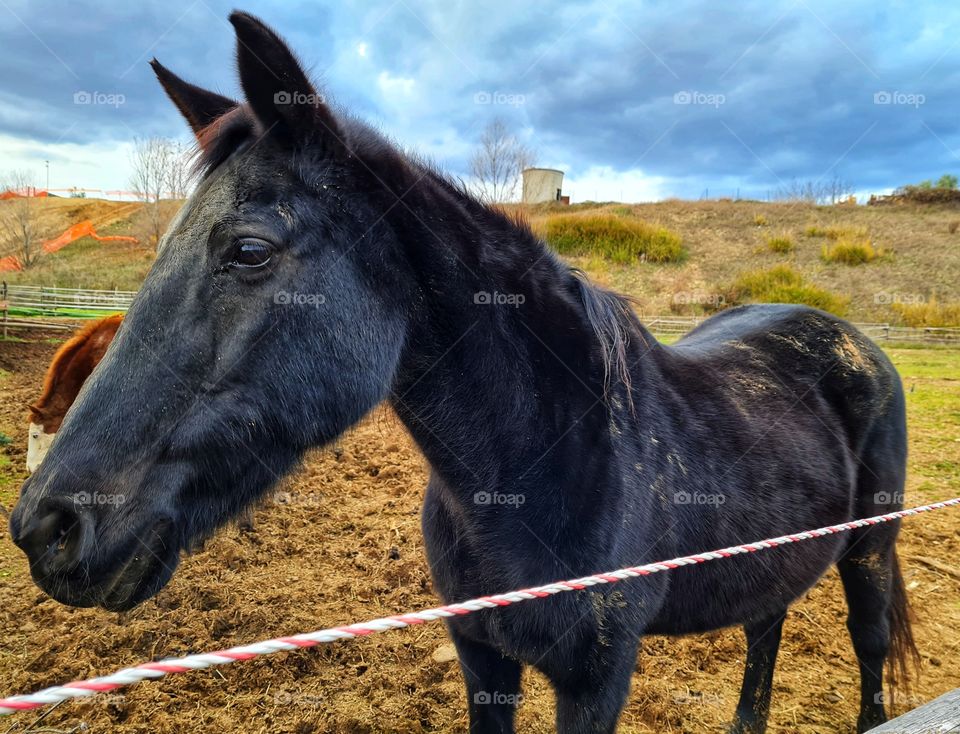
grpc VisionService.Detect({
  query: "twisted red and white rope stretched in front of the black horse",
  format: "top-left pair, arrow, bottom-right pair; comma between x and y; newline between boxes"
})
0,497 -> 960,716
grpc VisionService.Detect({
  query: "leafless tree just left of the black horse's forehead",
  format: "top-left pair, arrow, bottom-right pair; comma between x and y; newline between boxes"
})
130,138 -> 188,247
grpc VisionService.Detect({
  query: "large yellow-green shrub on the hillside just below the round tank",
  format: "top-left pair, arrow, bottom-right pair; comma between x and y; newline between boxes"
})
545,214 -> 686,263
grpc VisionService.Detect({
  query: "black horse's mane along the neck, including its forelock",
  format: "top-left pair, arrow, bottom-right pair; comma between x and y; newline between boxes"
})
194,104 -> 649,411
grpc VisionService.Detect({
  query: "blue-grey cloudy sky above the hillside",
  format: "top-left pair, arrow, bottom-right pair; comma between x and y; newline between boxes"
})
0,0 -> 960,201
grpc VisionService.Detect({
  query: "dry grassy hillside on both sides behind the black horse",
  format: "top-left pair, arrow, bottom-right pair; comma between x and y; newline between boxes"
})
5,200 -> 960,325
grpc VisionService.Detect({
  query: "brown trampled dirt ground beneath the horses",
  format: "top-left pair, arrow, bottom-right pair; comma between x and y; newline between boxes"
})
0,337 -> 960,734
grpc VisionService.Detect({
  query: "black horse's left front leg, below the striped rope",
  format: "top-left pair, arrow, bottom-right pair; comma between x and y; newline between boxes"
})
447,624 -> 521,734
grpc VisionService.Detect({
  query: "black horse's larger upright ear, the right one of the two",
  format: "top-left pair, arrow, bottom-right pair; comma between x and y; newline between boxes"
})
230,11 -> 343,152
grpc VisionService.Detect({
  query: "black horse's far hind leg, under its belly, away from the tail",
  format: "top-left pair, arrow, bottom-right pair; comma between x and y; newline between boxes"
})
730,611 -> 786,734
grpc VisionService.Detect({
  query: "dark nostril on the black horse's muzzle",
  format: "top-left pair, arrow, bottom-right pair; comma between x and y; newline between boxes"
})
15,505 -> 91,576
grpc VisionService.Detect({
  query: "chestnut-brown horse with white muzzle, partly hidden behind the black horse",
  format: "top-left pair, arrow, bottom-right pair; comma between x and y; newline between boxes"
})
27,314 -> 123,473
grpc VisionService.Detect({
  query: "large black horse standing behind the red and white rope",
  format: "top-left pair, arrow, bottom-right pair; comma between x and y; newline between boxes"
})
11,13 -> 916,732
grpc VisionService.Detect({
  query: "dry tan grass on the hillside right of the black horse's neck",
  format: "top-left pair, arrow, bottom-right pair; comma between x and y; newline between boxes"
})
528,201 -> 960,326
